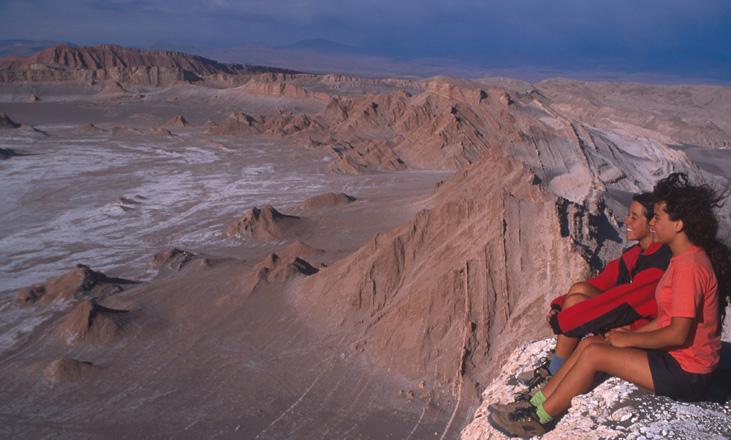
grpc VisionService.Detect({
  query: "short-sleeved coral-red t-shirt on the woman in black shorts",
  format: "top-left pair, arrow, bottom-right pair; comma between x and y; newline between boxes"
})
655,247 -> 721,374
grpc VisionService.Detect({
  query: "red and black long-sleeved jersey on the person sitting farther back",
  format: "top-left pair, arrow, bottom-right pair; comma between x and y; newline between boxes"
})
551,243 -> 672,337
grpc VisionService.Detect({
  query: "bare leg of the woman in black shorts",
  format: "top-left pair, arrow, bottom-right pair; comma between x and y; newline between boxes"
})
543,344 -> 655,415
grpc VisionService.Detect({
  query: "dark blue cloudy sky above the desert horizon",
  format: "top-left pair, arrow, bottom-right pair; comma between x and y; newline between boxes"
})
0,0 -> 731,81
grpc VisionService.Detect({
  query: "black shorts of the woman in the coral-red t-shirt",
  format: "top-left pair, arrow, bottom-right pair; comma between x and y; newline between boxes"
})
647,350 -> 711,402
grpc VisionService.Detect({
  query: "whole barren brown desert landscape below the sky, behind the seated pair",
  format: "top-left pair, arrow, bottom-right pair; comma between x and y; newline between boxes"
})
0,46 -> 731,439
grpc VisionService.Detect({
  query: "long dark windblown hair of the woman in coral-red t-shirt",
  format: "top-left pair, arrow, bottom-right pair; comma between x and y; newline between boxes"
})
652,173 -> 731,322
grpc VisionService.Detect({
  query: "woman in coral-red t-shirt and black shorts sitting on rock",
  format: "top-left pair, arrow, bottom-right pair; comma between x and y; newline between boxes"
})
489,173 -> 731,436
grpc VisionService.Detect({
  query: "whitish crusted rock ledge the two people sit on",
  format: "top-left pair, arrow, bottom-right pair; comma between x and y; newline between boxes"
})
461,339 -> 731,440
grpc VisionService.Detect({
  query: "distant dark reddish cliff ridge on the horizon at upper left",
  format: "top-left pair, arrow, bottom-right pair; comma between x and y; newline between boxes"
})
0,45 -> 292,86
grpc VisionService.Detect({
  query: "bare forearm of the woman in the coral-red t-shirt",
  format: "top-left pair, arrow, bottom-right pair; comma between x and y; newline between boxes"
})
607,318 -> 693,349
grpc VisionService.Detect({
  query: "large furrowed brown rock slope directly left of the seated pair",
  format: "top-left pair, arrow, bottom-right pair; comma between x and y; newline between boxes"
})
296,147 -> 604,413
